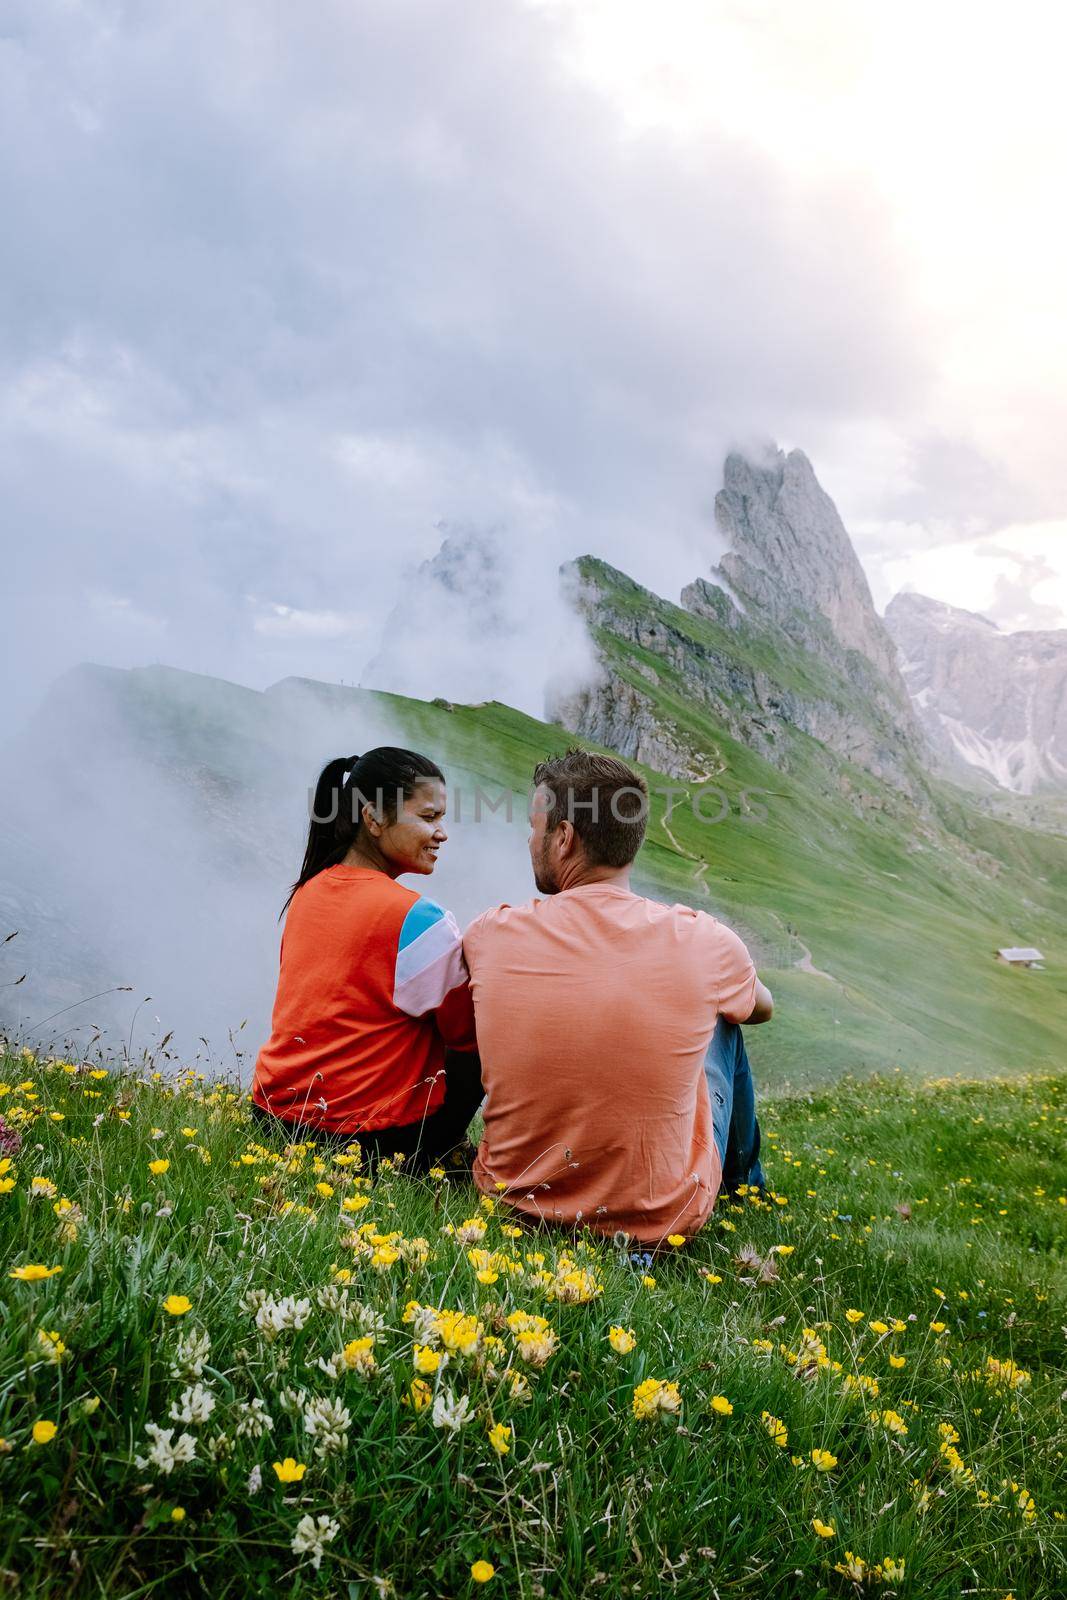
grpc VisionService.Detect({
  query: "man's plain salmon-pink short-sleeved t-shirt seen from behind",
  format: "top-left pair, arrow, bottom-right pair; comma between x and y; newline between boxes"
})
464,883 -> 757,1243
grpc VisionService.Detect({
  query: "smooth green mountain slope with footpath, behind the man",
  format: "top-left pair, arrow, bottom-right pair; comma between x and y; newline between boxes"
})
394,691 -> 1067,1085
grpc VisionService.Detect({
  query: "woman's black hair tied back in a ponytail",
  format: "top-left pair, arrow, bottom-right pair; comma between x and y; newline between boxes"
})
282,744 -> 445,915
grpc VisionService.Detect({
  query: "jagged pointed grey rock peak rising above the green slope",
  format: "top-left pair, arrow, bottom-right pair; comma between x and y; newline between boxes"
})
549,450 -> 929,808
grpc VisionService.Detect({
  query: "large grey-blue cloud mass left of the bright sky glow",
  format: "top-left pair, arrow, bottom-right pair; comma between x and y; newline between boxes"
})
0,0 -> 926,736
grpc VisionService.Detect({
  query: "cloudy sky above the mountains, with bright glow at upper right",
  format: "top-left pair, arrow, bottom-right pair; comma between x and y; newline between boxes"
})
0,0 -> 1067,732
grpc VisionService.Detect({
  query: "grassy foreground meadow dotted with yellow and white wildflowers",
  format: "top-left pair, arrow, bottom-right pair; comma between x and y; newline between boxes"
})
0,1053 -> 1067,1600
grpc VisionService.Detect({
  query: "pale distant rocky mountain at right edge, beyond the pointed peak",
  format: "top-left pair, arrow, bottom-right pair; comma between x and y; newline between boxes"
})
886,594 -> 1067,794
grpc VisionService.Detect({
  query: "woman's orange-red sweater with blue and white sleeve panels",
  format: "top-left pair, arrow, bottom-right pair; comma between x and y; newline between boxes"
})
253,866 -> 475,1138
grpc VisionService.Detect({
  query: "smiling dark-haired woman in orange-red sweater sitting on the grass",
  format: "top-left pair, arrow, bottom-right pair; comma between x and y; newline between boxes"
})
253,746 -> 482,1171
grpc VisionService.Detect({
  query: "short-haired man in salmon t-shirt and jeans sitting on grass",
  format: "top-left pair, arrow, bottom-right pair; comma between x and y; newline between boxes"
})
464,750 -> 773,1245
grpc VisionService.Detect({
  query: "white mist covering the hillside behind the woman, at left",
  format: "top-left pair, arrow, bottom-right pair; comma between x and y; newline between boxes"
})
0,669 -> 547,1077
